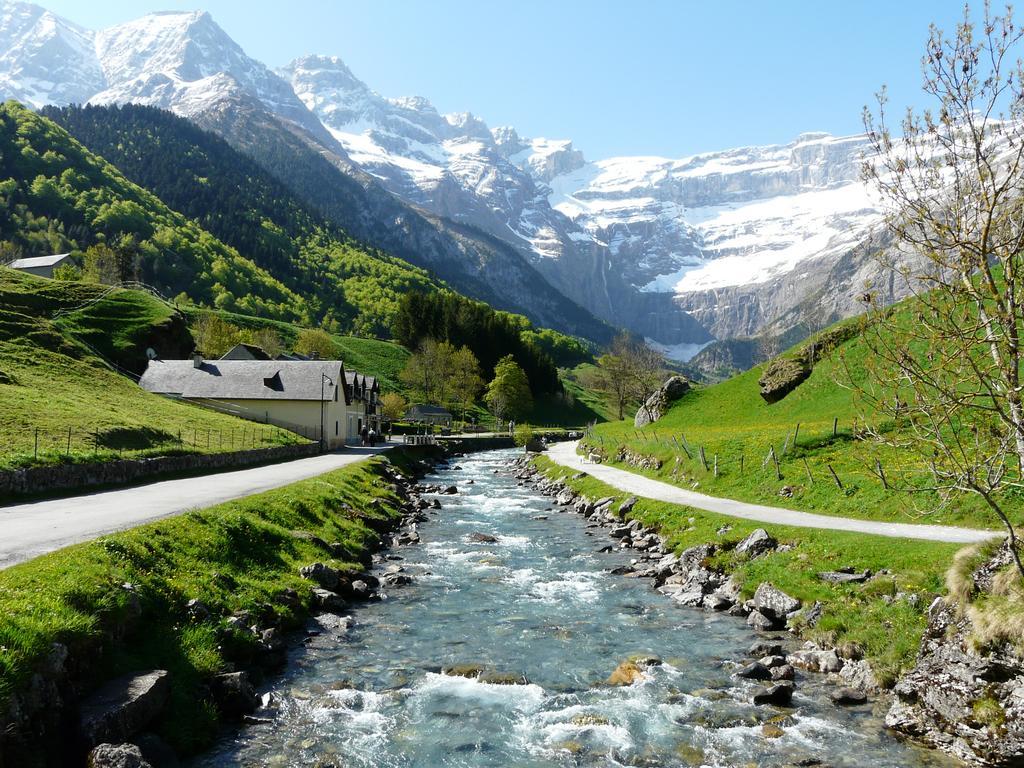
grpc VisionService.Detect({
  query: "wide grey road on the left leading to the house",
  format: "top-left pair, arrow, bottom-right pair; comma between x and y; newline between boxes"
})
0,445 -> 388,568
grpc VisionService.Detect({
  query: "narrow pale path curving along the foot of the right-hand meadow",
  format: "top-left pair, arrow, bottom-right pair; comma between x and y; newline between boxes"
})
548,442 -> 1001,544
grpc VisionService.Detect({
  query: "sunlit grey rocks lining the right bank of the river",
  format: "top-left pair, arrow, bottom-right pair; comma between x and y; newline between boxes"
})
514,460 -> 880,707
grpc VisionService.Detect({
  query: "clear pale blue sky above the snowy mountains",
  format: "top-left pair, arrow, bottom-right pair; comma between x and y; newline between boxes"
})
38,0 -> 963,158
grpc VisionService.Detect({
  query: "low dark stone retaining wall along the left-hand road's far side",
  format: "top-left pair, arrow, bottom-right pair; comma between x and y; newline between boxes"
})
0,442 -> 319,500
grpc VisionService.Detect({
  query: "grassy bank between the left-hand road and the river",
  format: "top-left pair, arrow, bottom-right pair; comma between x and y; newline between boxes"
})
0,449 -> 430,753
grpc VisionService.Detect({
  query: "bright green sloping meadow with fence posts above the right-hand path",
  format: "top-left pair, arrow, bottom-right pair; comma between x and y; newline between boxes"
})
590,309 -> 1024,528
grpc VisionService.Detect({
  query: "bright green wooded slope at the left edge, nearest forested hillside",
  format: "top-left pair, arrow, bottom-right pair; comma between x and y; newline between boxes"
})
0,101 -> 303,322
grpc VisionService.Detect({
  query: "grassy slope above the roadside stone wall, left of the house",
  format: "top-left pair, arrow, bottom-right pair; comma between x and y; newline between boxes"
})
0,269 -> 300,468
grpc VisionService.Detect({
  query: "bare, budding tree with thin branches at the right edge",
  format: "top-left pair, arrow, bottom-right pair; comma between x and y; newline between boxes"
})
860,3 -> 1024,579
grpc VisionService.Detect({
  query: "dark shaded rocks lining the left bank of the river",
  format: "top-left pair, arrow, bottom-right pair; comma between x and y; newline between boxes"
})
0,444 -> 458,768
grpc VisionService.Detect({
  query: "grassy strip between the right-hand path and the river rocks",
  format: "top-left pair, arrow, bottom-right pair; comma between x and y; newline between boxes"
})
537,457 -> 961,684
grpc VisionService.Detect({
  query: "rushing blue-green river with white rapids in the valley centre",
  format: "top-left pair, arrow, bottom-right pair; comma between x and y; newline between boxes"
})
197,451 -> 953,768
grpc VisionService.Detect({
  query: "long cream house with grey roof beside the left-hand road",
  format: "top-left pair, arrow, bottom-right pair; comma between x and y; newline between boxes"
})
139,355 -> 379,447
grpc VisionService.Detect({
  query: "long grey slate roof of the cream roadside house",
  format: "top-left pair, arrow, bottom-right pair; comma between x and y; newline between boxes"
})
139,359 -> 347,403
